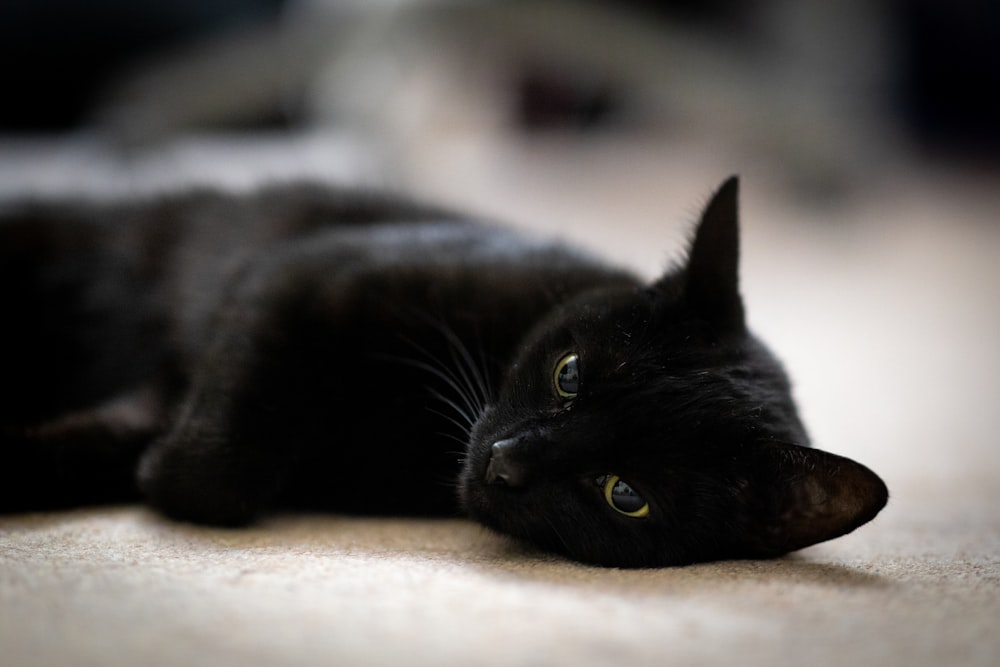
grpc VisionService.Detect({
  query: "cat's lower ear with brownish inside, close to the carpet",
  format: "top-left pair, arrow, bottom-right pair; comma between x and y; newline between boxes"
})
748,444 -> 889,555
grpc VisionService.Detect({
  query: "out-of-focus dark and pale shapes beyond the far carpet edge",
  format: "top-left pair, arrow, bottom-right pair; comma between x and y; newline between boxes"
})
0,0 -> 1000,194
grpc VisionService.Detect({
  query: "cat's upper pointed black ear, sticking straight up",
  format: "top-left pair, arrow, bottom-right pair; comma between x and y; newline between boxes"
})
682,176 -> 744,331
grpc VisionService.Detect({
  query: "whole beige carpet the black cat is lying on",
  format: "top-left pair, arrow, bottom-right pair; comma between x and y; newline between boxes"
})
0,133 -> 1000,667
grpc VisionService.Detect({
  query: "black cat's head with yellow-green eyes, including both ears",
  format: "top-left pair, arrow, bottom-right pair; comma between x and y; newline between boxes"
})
460,178 -> 888,567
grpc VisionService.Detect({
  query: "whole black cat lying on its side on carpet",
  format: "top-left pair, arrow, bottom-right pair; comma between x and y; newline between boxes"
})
0,178 -> 887,567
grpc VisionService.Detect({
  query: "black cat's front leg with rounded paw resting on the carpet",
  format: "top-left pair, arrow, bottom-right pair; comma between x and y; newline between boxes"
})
138,250 -> 350,525
